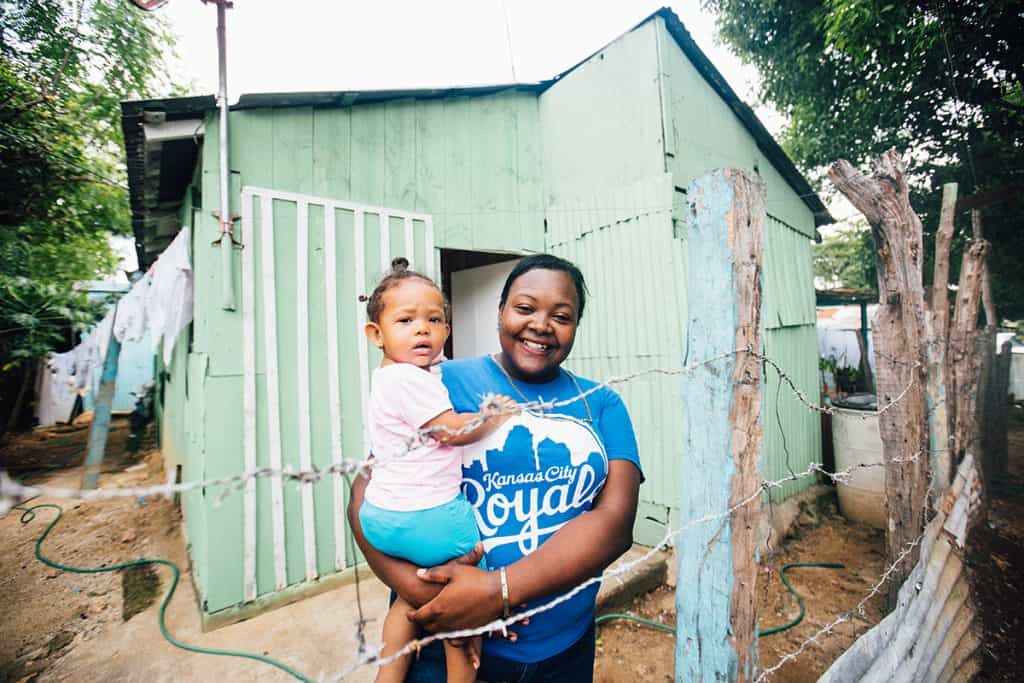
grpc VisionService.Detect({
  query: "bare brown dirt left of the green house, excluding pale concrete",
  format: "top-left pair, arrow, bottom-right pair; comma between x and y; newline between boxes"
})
0,421 -> 174,681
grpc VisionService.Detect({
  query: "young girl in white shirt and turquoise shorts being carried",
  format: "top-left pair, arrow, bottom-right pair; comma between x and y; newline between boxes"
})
359,257 -> 515,682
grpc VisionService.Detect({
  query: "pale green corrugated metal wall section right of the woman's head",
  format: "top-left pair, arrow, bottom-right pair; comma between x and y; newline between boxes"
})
547,175 -> 687,524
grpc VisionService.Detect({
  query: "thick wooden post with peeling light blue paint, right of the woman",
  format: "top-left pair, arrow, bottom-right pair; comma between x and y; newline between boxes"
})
676,169 -> 765,681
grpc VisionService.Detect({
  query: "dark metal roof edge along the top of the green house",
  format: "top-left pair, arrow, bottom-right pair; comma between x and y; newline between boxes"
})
121,7 -> 836,267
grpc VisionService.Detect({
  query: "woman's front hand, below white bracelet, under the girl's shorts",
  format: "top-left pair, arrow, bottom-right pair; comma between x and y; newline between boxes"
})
409,561 -> 502,633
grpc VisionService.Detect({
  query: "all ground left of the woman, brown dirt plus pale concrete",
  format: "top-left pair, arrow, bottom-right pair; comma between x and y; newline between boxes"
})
0,423 -> 387,683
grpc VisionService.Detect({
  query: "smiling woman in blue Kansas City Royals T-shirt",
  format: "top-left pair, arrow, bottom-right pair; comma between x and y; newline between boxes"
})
349,254 -> 643,682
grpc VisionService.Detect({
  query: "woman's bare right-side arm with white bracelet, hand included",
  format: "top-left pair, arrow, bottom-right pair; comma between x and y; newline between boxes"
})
410,460 -> 641,633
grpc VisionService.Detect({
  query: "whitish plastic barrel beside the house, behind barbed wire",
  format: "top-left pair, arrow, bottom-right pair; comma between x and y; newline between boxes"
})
831,405 -> 887,529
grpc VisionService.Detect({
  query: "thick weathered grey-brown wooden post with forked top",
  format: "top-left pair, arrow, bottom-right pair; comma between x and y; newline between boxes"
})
828,150 -> 929,606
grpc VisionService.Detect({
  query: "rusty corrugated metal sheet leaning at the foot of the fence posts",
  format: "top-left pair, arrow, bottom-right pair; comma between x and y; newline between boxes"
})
818,455 -> 981,683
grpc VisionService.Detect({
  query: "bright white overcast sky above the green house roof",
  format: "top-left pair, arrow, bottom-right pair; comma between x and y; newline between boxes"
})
157,0 -> 782,132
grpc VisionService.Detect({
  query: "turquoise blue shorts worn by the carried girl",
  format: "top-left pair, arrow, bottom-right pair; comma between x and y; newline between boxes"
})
359,494 -> 483,567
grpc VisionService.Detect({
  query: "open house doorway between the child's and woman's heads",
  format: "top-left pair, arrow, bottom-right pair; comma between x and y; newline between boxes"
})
441,249 -> 521,358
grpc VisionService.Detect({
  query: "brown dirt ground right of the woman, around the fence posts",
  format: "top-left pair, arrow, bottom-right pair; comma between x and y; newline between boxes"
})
595,409 -> 1024,683
